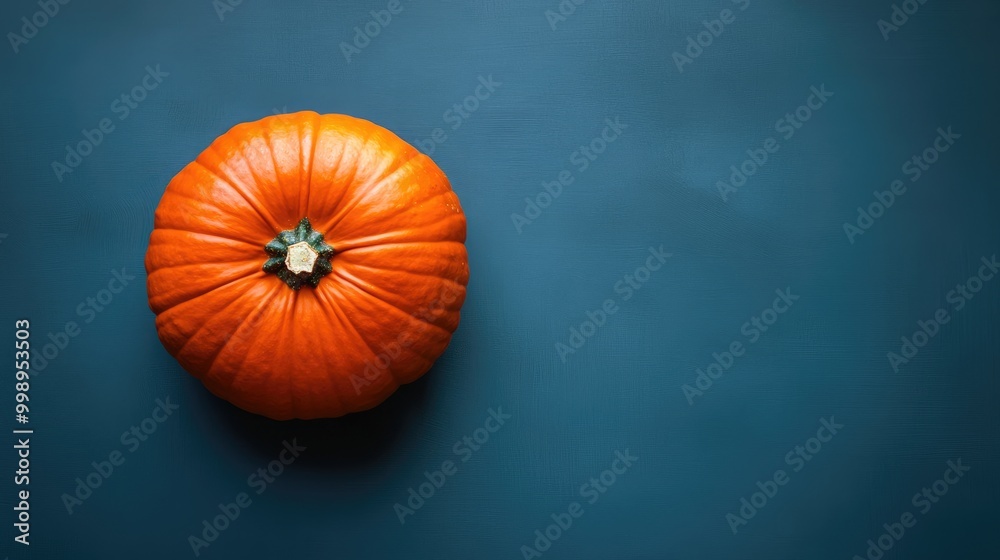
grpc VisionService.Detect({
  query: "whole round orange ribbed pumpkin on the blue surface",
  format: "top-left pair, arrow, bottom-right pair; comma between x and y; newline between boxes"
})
145,112 -> 469,420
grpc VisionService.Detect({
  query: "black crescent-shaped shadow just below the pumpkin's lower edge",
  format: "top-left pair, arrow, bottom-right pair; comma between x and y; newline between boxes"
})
202,369 -> 435,471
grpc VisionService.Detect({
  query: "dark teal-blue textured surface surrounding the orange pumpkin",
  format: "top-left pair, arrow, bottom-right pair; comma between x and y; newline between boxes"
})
0,0 -> 1000,560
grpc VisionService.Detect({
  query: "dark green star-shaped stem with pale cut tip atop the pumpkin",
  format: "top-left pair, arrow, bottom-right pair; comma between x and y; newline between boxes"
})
263,218 -> 336,290
